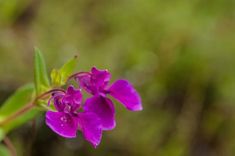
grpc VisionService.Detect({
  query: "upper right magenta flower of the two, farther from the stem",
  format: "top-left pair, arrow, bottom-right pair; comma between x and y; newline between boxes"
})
75,67 -> 142,130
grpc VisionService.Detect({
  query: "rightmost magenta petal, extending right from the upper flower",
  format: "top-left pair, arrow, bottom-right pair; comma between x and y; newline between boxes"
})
109,80 -> 143,111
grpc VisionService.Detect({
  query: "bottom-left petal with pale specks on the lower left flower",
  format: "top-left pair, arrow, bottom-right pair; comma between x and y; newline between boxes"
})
46,111 -> 78,138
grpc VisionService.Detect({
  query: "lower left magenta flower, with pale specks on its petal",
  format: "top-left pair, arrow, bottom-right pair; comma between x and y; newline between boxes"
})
46,86 -> 102,147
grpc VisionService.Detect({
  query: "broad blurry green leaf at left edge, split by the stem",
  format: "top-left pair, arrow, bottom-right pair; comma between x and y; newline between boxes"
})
0,84 -> 39,133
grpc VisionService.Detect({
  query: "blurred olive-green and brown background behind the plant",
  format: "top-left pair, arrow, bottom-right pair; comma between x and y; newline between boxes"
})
0,0 -> 235,156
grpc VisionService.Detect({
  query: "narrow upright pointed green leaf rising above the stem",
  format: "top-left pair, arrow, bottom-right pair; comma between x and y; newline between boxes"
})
34,48 -> 50,95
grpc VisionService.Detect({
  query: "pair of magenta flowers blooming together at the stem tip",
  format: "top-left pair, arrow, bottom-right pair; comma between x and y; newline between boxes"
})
46,67 -> 142,147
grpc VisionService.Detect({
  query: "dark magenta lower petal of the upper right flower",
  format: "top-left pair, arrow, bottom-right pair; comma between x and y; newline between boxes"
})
84,95 -> 116,130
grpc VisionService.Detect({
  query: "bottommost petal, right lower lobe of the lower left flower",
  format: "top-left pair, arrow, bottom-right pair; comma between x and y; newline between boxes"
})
78,112 -> 102,148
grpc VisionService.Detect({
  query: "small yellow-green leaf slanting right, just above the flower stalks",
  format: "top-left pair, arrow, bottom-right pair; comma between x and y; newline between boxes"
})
51,56 -> 77,86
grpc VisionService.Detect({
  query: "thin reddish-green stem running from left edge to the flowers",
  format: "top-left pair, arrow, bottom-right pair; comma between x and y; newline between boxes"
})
0,89 -> 65,127
